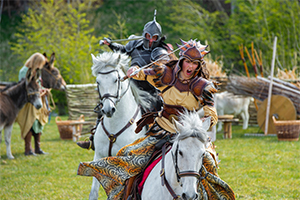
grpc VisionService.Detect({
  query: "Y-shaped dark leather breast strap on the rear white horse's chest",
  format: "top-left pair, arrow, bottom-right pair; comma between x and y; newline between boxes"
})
101,106 -> 140,156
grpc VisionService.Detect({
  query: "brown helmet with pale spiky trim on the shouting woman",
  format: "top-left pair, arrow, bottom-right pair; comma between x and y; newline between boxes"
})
176,39 -> 210,77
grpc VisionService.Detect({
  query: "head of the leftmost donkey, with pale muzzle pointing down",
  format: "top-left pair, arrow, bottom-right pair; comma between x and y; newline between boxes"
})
25,68 -> 42,109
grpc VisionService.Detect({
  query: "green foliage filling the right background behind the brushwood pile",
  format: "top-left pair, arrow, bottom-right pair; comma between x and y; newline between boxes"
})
169,0 -> 300,74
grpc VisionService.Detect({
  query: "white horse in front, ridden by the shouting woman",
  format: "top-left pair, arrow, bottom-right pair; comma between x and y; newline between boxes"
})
141,112 -> 210,200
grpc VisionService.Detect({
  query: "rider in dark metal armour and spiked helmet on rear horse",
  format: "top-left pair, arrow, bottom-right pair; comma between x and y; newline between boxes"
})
77,10 -> 176,150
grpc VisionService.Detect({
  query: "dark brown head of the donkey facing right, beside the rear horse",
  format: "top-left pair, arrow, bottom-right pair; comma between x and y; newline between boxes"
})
42,53 -> 66,91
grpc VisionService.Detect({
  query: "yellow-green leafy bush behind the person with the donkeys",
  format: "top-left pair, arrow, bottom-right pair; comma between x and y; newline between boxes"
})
12,0 -> 103,83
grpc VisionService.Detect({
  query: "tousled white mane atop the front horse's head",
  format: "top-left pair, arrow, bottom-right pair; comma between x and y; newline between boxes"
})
172,110 -> 208,143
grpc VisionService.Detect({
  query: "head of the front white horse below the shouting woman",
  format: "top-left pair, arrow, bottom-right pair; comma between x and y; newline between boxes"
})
171,112 -> 210,199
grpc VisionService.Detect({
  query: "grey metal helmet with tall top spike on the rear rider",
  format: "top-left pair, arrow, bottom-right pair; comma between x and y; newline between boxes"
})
143,10 -> 162,50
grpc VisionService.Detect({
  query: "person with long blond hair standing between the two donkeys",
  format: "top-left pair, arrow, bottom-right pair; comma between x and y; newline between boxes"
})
16,53 -> 50,156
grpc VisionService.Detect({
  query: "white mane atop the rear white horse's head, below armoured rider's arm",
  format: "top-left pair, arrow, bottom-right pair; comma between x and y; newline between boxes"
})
92,52 -> 130,76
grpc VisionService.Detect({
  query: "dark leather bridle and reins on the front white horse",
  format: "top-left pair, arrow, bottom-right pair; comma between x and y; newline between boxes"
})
160,141 -> 207,200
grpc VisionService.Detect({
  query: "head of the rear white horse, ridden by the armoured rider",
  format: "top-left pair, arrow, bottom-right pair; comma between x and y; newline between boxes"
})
92,52 -> 129,117
